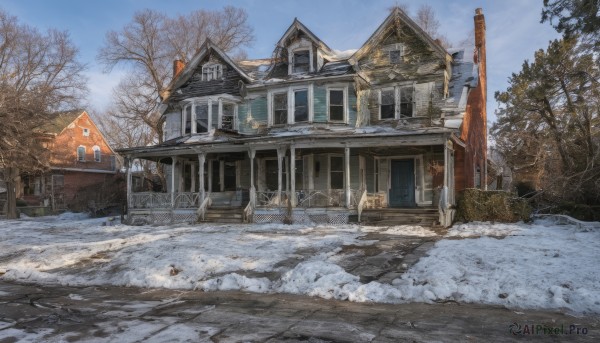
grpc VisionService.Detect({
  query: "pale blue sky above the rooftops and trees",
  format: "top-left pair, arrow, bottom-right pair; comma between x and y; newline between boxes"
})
0,0 -> 559,120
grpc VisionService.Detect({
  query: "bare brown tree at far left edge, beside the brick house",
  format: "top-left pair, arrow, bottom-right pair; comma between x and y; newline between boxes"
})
0,10 -> 86,218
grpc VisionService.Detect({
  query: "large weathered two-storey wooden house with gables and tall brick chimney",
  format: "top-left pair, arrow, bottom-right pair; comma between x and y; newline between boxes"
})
119,9 -> 487,225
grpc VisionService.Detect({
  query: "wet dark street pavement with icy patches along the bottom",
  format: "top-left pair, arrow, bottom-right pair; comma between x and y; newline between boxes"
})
0,282 -> 600,343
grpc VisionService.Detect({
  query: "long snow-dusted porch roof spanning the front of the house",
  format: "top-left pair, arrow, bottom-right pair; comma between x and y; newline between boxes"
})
117,127 -> 456,158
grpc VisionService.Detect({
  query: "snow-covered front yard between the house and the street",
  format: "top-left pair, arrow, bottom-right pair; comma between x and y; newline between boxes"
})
0,214 -> 600,314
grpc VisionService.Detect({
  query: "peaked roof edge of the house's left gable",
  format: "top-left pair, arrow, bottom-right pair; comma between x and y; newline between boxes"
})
160,38 -> 252,103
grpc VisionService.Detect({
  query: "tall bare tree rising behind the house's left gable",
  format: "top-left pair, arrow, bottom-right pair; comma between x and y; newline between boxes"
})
98,6 -> 253,150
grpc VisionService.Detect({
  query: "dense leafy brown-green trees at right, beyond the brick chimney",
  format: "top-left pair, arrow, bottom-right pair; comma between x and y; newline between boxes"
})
490,0 -> 600,219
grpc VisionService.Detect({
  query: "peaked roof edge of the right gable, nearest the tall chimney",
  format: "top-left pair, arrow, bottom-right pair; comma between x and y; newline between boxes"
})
350,7 -> 448,64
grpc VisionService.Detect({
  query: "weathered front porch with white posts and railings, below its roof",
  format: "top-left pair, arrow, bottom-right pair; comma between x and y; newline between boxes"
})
127,136 -> 454,224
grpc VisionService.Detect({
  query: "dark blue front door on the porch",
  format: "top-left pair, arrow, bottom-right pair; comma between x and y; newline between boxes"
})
390,160 -> 416,207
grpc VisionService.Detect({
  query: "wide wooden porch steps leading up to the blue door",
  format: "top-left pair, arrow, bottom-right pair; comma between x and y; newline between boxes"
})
361,208 -> 439,226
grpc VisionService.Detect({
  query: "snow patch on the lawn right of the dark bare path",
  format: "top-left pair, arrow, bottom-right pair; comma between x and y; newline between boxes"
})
394,221 -> 600,313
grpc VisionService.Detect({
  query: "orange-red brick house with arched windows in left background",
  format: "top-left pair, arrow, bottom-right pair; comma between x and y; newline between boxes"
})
17,110 -> 118,210
